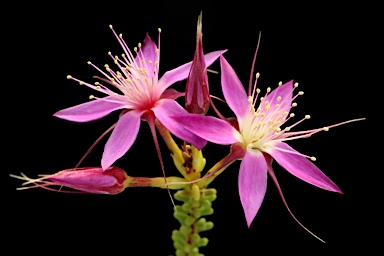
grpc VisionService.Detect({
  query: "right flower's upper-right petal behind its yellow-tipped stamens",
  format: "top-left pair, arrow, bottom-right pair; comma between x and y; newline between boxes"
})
263,80 -> 293,115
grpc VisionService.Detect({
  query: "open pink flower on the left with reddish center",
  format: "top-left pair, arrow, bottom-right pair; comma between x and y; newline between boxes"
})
54,26 -> 225,170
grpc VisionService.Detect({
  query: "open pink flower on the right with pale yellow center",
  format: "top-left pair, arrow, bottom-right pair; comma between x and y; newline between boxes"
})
173,56 -> 362,229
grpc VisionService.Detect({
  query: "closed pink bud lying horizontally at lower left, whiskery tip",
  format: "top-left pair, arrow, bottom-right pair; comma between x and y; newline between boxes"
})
11,167 -> 130,195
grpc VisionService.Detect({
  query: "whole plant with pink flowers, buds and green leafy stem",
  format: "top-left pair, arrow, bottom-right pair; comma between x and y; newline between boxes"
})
11,14 -> 363,256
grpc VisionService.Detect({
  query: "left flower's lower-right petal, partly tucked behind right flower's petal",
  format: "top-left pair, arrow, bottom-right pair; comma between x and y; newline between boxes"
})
152,99 -> 207,150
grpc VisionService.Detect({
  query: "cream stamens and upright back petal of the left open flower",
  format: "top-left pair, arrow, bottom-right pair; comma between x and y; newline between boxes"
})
67,25 -> 162,110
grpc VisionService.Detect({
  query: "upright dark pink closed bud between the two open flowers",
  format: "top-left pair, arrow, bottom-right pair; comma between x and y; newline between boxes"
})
185,14 -> 211,115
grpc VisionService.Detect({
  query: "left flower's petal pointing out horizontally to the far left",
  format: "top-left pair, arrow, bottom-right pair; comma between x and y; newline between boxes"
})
53,96 -> 126,122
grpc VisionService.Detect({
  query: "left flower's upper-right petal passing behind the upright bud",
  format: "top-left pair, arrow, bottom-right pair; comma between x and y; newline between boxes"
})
158,50 -> 227,90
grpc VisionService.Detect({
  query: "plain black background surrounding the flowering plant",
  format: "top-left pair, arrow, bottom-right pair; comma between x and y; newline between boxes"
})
1,1 -> 369,255
